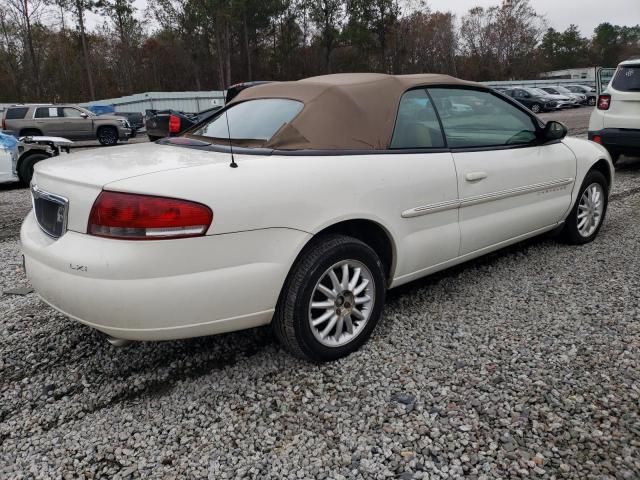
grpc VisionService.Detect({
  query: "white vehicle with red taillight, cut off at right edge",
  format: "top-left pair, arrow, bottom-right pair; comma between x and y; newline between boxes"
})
589,58 -> 640,163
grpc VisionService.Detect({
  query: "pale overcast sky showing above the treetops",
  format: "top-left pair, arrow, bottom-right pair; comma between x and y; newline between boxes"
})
88,0 -> 640,37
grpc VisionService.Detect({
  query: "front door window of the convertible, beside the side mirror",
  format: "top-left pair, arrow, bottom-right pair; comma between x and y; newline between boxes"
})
429,88 -> 537,148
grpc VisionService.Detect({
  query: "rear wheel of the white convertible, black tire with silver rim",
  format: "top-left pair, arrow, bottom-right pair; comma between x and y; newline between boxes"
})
273,235 -> 386,362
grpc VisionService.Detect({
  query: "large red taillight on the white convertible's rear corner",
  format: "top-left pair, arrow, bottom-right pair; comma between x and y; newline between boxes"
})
87,191 -> 213,240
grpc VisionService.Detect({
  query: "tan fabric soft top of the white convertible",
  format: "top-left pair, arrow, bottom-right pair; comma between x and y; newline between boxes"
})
230,73 -> 482,150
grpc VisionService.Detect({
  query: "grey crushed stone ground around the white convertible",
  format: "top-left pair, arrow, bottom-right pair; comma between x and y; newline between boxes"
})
0,159 -> 640,480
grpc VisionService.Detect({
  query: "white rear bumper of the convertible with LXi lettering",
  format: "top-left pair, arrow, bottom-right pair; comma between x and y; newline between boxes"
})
20,213 -> 310,340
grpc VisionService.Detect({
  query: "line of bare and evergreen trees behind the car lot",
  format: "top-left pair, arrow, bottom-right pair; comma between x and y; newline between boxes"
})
0,0 -> 640,102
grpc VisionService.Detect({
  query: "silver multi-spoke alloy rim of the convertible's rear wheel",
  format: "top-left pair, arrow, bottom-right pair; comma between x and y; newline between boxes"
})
309,260 -> 376,347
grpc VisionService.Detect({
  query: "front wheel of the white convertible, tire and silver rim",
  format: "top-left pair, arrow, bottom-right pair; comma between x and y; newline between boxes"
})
562,170 -> 609,245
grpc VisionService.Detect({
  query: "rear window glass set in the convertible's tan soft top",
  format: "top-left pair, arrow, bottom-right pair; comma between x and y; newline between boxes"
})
189,98 -> 303,147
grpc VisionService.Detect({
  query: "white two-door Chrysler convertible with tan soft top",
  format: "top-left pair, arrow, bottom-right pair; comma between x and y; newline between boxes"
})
21,74 -> 613,361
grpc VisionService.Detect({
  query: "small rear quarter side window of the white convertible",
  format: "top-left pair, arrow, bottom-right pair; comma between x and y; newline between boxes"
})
391,89 -> 444,149
